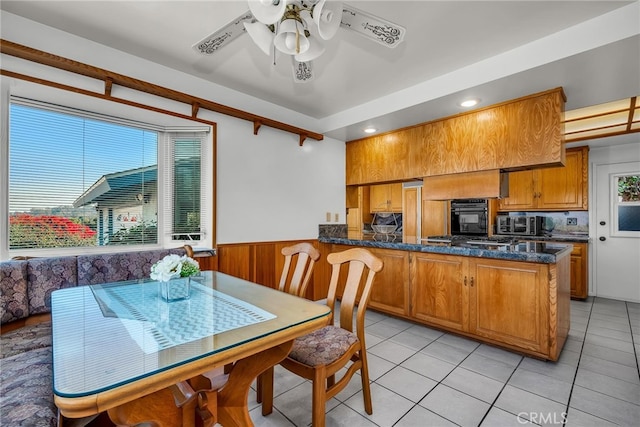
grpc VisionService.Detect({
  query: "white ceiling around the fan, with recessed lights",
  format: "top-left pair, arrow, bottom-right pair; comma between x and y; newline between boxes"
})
0,0 -> 640,141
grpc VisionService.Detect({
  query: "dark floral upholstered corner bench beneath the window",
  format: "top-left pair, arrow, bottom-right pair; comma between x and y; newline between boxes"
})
0,247 -> 191,427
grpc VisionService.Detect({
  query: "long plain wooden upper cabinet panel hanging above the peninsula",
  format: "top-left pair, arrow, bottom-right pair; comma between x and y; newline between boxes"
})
346,88 -> 565,185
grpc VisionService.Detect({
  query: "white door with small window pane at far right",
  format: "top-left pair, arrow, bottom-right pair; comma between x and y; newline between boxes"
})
591,162 -> 640,302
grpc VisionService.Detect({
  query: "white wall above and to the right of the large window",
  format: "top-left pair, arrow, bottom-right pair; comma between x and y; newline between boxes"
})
0,12 -> 346,254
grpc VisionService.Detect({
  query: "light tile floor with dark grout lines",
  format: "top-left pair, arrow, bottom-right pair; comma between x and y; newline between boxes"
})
249,298 -> 640,427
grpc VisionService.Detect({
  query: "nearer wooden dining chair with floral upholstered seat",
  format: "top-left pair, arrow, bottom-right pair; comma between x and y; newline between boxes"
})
262,248 -> 383,427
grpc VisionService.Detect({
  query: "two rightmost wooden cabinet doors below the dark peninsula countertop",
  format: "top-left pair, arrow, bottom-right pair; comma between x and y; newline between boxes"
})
410,253 -> 548,354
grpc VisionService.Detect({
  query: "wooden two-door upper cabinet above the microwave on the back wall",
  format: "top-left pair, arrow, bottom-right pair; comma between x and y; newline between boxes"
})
499,147 -> 589,211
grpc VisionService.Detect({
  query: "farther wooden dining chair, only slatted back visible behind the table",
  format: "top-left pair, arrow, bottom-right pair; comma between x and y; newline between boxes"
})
278,242 -> 320,298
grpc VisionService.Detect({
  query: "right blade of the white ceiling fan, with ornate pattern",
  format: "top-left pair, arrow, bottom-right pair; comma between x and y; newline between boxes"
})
340,4 -> 407,48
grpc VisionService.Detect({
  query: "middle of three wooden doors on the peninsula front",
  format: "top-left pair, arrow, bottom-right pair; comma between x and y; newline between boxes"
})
410,252 -> 469,331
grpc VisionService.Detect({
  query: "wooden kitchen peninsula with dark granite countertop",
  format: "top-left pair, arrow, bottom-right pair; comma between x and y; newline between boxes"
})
319,235 -> 572,361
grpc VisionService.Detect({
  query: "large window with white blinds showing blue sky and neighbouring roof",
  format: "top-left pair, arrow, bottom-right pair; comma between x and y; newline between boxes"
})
3,99 -> 208,252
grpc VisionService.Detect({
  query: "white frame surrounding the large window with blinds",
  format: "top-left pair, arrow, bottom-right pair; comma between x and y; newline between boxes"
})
0,94 -> 216,259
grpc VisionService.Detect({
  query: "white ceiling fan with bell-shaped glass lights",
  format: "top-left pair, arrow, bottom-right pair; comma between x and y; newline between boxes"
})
193,0 -> 406,83
